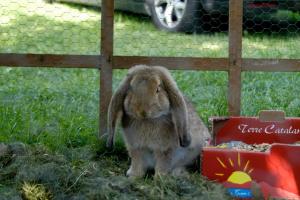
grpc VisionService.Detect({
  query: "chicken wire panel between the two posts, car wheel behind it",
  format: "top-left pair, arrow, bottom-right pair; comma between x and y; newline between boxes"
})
114,0 -> 228,57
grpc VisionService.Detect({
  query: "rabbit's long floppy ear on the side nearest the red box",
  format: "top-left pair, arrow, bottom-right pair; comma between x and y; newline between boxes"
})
155,67 -> 190,147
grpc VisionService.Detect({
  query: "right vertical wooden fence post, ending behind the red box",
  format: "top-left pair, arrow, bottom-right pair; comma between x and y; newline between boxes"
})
228,0 -> 243,116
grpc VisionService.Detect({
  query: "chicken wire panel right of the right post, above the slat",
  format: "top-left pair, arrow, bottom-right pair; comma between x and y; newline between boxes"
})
243,0 -> 300,59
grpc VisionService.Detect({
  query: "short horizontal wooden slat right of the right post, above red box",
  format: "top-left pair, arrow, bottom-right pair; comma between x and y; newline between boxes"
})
242,59 -> 300,72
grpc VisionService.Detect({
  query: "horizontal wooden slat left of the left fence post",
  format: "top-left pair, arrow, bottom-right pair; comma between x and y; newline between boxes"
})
0,54 -> 101,68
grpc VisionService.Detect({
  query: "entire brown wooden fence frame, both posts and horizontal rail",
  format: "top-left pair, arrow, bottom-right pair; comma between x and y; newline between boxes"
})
0,0 -> 300,138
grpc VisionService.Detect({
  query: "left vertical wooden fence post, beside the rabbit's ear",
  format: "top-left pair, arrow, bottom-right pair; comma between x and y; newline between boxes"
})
99,0 -> 114,136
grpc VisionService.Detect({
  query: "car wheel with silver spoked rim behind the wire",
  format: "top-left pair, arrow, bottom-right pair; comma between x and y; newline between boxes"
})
147,0 -> 200,32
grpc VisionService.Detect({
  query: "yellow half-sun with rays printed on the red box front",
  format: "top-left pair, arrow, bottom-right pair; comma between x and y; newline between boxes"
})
215,153 -> 253,185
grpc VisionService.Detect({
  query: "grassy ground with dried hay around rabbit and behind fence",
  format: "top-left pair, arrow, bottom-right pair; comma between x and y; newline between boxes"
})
0,0 -> 300,199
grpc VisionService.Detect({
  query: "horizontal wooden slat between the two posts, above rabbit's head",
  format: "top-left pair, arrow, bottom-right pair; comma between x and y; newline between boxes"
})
113,56 -> 229,71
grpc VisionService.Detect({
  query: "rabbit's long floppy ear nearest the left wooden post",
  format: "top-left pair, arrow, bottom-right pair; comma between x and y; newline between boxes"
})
106,75 -> 131,148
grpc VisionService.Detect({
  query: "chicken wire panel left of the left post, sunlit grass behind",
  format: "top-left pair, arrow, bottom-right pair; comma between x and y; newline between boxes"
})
0,0 -> 100,55
